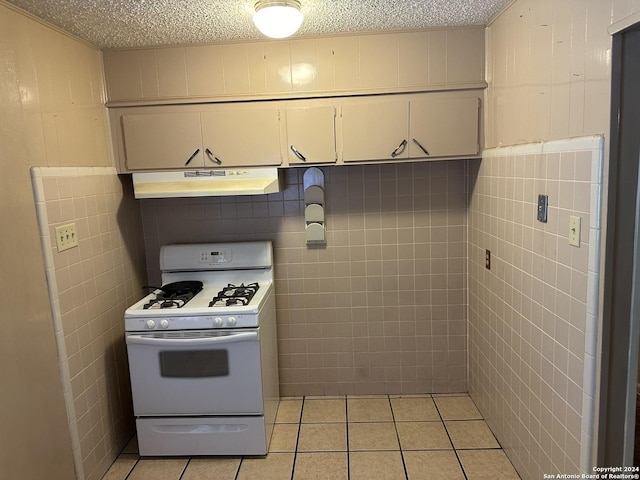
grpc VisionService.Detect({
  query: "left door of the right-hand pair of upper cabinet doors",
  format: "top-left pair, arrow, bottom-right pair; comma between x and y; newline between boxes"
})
341,100 -> 409,162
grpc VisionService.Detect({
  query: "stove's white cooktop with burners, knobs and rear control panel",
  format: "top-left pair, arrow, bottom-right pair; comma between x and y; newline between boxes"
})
125,242 -> 273,332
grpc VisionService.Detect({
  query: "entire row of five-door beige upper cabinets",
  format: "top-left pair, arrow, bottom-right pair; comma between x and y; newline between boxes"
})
111,90 -> 481,173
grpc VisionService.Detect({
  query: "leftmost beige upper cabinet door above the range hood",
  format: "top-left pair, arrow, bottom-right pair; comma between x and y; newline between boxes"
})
122,112 -> 204,170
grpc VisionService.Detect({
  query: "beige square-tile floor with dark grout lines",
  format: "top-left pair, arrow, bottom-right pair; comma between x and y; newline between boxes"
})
103,394 -> 520,480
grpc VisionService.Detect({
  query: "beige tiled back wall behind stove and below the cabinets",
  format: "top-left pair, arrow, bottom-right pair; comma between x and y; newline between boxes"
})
141,161 -> 473,395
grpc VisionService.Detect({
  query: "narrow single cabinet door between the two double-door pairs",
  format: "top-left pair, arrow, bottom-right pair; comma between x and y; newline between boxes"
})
286,106 -> 336,164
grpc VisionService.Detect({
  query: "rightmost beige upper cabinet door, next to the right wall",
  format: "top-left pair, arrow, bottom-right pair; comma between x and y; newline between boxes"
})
409,97 -> 480,158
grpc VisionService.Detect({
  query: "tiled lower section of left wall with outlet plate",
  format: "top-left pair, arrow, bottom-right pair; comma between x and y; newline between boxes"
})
32,167 -> 146,480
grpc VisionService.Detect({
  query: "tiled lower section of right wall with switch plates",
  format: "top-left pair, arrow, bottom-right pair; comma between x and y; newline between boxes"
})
469,137 -> 604,479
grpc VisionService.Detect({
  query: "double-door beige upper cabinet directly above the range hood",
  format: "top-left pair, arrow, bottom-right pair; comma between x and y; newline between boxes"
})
117,106 -> 282,171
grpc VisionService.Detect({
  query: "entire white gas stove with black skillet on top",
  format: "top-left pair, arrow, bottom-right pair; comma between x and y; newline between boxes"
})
125,242 -> 279,455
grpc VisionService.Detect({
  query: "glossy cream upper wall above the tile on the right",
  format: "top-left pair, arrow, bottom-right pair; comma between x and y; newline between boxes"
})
485,0 -> 640,148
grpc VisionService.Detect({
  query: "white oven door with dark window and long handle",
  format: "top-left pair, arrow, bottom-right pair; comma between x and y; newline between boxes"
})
126,329 -> 264,416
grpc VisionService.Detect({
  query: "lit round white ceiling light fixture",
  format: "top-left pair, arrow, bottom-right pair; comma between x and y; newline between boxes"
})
253,0 -> 303,38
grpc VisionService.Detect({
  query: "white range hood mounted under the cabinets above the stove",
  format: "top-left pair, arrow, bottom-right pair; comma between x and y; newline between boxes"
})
133,167 -> 280,198
